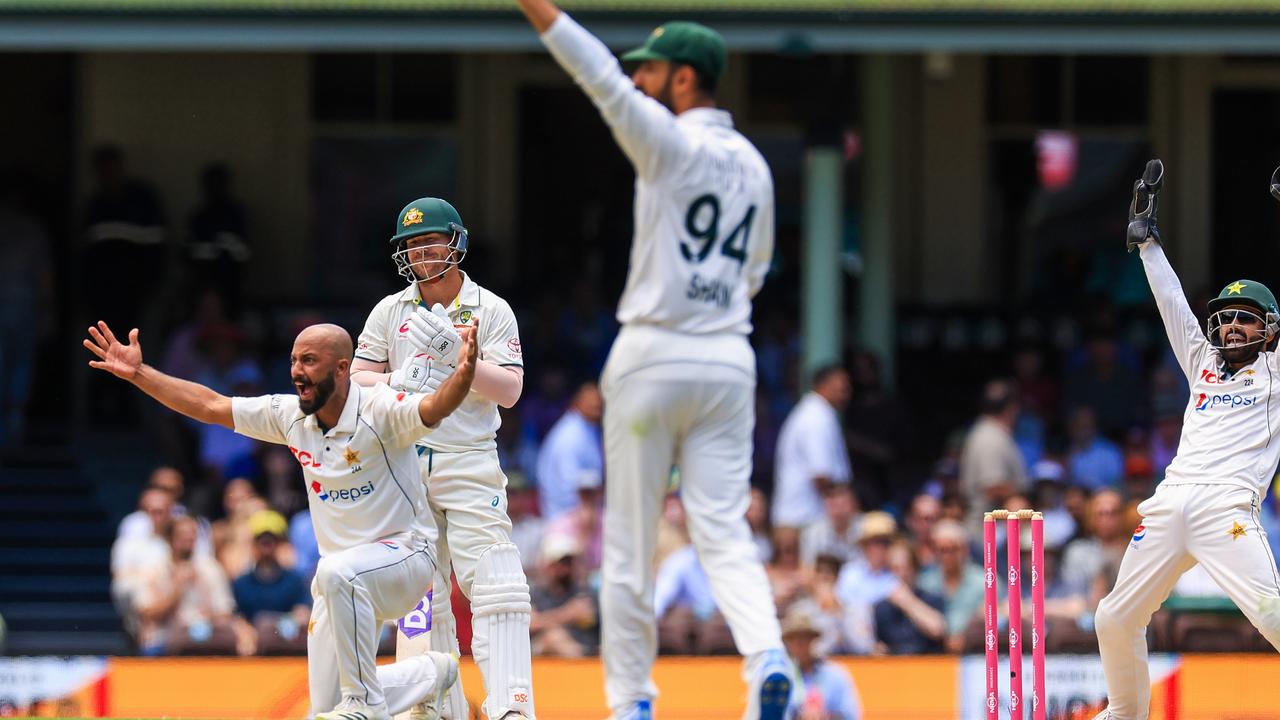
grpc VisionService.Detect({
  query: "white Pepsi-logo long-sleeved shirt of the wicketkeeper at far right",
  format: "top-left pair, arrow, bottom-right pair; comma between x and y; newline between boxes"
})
1142,242 -> 1280,497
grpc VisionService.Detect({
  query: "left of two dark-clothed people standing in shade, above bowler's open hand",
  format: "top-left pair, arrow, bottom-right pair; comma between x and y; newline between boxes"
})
84,145 -> 166,425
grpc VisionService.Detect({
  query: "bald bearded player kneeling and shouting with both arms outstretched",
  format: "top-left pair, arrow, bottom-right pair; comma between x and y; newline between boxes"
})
84,322 -> 476,720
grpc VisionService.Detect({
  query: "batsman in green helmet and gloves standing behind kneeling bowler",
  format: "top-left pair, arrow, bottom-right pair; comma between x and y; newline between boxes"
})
352,197 -> 534,720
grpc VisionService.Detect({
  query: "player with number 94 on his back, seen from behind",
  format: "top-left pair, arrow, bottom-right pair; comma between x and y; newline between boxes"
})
520,0 -> 792,720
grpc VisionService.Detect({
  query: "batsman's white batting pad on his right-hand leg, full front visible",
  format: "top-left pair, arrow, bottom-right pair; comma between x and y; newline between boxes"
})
471,543 -> 534,719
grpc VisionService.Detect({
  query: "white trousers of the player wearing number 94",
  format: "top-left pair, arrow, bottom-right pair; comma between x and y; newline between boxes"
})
600,361 -> 782,712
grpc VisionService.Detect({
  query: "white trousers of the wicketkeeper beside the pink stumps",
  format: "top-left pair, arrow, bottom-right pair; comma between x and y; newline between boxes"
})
1094,484 -> 1280,720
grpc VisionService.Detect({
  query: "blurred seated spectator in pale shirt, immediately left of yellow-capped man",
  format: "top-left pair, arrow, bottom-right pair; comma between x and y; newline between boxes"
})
134,518 -> 236,655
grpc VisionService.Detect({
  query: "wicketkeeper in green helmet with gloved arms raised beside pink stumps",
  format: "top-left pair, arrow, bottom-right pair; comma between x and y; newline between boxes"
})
1096,160 -> 1280,720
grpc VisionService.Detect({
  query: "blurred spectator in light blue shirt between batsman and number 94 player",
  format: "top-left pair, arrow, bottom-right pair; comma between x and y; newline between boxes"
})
538,383 -> 604,521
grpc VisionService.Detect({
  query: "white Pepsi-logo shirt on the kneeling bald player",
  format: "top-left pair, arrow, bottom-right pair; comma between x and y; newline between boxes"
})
232,383 -> 435,556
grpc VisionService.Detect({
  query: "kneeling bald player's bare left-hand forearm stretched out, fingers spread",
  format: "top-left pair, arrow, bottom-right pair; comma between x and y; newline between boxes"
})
84,320 -> 236,429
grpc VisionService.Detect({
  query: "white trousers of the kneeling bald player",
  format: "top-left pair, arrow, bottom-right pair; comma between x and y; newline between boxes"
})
307,534 -> 436,715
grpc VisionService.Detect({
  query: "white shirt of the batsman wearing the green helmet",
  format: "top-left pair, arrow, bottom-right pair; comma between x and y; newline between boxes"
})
356,273 -> 524,452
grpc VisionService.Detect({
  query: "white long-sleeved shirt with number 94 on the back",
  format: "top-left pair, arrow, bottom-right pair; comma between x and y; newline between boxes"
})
543,13 -> 773,337
